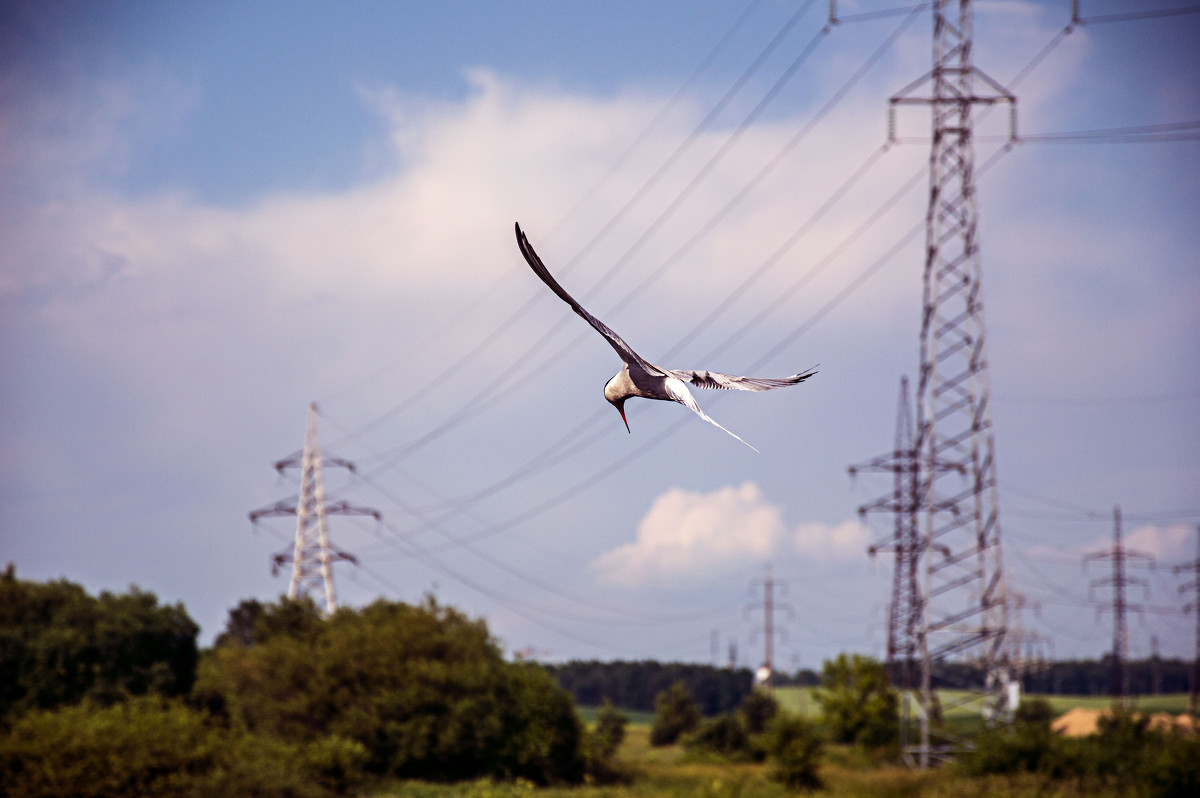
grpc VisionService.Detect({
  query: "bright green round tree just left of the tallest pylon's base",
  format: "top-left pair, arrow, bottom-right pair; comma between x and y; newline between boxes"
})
816,654 -> 899,748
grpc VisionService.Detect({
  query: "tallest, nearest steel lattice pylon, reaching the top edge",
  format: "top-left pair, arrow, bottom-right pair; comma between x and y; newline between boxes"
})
889,0 -> 1016,767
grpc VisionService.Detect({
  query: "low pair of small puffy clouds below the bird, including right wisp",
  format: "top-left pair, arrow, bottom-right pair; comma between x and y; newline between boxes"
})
592,481 -> 870,587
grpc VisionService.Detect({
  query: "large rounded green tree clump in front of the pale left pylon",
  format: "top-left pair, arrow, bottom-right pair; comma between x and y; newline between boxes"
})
196,590 -> 583,784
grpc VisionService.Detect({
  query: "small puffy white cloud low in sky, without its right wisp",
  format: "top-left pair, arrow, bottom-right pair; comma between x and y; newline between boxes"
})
592,482 -> 784,586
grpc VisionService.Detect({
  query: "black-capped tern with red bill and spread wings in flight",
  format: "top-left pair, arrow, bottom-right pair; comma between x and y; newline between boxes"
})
516,222 -> 817,451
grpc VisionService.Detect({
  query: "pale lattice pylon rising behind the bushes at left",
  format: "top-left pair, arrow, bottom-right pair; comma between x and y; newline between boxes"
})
250,404 -> 380,614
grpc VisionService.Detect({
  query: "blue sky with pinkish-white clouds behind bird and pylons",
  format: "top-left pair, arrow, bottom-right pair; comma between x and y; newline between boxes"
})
0,0 -> 1200,671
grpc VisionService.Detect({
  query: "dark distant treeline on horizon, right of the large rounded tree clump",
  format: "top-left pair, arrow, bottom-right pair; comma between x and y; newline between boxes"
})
546,660 -> 754,716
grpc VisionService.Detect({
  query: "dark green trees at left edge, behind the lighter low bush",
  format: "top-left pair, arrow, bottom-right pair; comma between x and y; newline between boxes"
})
0,565 -> 199,718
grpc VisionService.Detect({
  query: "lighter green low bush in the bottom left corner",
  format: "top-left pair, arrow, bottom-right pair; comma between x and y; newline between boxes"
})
0,697 -> 328,798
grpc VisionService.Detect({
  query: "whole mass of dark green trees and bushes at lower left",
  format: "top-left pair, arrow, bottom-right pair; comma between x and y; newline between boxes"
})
0,566 -> 597,798
